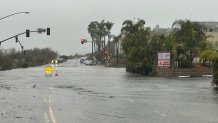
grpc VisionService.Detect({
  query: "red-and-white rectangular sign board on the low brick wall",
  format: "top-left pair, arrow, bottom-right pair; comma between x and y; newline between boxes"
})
157,52 -> 170,68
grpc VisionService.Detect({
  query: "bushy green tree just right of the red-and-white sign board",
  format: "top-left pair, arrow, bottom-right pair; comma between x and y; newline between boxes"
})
172,20 -> 207,67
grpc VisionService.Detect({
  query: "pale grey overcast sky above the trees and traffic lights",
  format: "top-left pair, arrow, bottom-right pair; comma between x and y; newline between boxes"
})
0,0 -> 218,55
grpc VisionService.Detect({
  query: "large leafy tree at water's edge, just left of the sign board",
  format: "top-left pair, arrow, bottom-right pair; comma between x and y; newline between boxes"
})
121,19 -> 162,75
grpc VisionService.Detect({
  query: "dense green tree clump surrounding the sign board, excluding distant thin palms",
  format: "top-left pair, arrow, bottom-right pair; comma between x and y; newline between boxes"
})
121,20 -> 211,75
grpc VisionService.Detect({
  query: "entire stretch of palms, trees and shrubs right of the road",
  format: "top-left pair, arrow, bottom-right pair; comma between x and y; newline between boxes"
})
88,19 -> 218,84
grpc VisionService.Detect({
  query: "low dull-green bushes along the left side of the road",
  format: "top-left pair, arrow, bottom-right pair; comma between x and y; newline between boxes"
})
0,48 -> 58,70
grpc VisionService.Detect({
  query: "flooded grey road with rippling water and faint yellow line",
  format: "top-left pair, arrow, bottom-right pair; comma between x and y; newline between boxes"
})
0,60 -> 218,123
